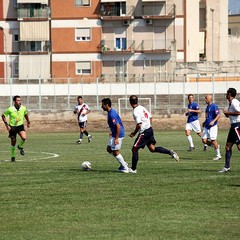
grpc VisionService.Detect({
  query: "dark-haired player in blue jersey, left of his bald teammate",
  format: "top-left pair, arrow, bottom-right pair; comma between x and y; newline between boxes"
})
185,94 -> 207,152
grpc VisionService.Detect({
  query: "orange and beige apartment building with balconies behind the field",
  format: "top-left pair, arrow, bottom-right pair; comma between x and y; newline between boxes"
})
0,0 -> 228,83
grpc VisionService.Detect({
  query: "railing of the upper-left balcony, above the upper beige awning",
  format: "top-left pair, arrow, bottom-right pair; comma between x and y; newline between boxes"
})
18,7 -> 50,19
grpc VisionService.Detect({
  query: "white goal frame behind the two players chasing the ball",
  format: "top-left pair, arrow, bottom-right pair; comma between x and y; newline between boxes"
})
118,98 -> 152,117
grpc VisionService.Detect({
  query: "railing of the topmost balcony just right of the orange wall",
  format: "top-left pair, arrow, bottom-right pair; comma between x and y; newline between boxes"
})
100,3 -> 134,20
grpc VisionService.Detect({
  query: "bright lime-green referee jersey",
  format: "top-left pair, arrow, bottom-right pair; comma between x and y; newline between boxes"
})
3,106 -> 27,126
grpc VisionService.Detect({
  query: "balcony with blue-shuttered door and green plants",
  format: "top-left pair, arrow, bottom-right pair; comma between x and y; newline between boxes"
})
101,38 -> 135,54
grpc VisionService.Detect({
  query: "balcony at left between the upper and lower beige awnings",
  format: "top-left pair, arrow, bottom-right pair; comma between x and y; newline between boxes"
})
18,41 -> 51,54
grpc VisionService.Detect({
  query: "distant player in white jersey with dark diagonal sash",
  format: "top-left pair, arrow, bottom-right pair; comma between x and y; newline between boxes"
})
73,96 -> 92,144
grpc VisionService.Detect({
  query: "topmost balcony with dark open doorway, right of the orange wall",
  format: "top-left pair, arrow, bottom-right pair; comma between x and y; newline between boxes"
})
100,2 -> 134,21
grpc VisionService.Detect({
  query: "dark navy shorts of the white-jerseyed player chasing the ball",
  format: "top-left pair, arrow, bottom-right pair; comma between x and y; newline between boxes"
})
133,127 -> 156,148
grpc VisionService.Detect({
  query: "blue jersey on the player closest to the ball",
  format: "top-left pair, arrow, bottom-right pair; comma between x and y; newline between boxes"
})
108,108 -> 124,138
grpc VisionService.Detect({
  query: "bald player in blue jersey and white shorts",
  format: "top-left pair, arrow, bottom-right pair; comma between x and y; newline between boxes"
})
202,94 -> 222,161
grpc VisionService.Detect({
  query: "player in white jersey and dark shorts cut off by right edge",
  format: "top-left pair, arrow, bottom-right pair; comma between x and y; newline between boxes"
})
219,88 -> 240,173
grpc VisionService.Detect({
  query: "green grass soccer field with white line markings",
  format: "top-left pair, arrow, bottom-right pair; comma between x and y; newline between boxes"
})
0,130 -> 240,240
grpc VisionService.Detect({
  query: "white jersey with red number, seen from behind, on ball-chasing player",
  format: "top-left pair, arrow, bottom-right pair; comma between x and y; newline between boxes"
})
133,105 -> 152,133
